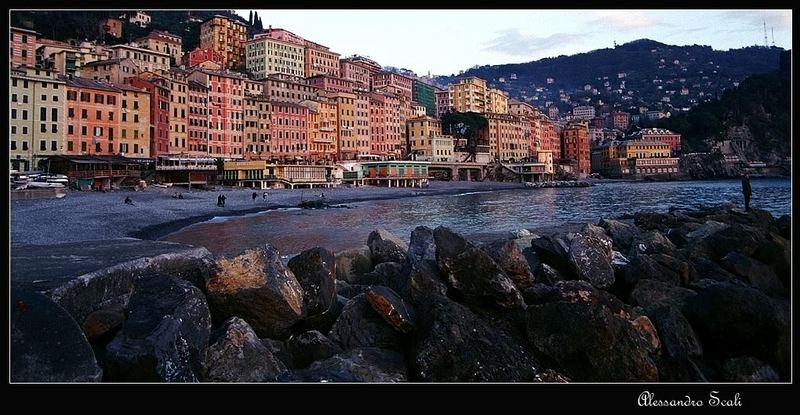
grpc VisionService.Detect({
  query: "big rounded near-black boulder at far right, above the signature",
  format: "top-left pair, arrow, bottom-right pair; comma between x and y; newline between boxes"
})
683,283 -> 790,368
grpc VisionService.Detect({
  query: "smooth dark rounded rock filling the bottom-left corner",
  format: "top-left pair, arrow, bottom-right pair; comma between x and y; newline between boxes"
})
9,289 -> 103,382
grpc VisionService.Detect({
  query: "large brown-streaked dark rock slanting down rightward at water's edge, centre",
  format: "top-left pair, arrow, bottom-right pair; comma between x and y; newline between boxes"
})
433,226 -> 525,309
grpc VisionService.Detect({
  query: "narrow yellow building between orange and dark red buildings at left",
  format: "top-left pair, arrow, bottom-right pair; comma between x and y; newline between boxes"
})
118,85 -> 150,157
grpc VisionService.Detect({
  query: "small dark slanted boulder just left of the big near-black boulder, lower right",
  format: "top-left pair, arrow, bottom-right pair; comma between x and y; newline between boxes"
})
648,305 -> 703,359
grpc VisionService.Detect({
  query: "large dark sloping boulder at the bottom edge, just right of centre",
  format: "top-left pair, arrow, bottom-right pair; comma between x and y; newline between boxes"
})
411,296 -> 537,382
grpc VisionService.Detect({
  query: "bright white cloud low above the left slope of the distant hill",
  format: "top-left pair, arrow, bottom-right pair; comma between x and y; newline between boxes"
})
483,29 -> 586,57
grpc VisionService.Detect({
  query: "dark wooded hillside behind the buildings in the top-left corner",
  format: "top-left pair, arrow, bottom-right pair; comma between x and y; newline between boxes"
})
11,10 -> 247,50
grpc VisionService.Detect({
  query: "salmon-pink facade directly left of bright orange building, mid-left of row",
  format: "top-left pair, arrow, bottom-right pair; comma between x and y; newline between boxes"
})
267,101 -> 308,161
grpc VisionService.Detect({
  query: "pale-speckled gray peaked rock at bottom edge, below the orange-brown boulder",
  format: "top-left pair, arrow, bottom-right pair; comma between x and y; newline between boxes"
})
204,317 -> 286,382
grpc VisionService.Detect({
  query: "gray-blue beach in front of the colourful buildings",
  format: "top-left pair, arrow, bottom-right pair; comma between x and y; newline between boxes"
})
10,181 -> 523,246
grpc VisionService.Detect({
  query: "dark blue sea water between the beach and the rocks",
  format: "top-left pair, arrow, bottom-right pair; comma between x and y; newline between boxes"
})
163,178 -> 791,255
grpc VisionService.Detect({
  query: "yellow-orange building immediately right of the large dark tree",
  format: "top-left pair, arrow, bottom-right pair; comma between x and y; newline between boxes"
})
485,114 -> 530,161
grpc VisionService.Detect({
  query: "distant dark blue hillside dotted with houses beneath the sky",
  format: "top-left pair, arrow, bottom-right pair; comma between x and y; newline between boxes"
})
436,39 -> 783,117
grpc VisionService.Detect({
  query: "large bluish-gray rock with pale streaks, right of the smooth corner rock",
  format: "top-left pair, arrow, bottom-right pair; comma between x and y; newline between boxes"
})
105,275 -> 211,382
